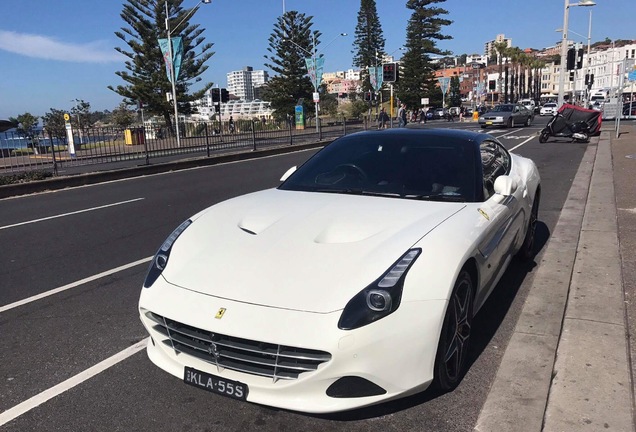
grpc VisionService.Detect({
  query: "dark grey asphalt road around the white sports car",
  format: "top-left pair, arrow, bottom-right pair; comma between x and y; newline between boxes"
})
0,117 -> 586,432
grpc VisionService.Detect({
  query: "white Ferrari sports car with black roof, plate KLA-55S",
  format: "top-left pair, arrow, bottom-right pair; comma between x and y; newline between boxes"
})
139,129 -> 540,413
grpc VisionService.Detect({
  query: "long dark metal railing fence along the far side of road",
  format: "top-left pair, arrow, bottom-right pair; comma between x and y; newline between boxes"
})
0,118 -> 375,175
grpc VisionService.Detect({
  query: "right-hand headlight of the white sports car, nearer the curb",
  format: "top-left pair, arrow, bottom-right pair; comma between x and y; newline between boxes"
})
338,249 -> 422,330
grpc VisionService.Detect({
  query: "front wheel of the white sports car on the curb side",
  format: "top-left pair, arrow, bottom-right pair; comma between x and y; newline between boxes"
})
433,269 -> 475,393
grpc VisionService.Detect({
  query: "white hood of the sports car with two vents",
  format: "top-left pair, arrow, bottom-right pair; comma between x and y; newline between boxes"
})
163,189 -> 465,313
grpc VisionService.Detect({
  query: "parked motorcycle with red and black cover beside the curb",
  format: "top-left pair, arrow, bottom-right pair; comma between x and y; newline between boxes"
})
539,104 -> 601,143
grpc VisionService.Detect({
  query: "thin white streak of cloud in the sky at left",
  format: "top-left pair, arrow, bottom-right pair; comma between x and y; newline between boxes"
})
0,30 -> 123,63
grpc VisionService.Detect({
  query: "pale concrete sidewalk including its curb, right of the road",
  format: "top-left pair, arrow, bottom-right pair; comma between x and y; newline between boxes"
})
475,122 -> 636,432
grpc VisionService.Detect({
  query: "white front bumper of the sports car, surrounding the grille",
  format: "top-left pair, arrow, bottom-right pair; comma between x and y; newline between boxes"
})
139,278 -> 447,413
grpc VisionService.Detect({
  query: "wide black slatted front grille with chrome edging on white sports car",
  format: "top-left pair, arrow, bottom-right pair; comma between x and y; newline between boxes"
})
146,312 -> 331,382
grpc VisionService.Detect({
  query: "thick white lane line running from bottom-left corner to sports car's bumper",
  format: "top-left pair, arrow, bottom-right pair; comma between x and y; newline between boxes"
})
0,338 -> 150,426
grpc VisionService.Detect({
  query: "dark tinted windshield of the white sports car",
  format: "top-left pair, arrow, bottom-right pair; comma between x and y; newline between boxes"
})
279,132 -> 476,202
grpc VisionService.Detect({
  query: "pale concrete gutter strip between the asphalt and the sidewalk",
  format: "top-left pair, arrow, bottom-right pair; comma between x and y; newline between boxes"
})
474,138 -> 597,432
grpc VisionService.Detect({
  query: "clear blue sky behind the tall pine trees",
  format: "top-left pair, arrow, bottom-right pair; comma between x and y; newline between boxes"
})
0,0 -> 636,118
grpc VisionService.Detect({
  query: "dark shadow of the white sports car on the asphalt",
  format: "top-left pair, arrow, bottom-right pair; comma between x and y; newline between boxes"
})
313,221 -> 550,422
